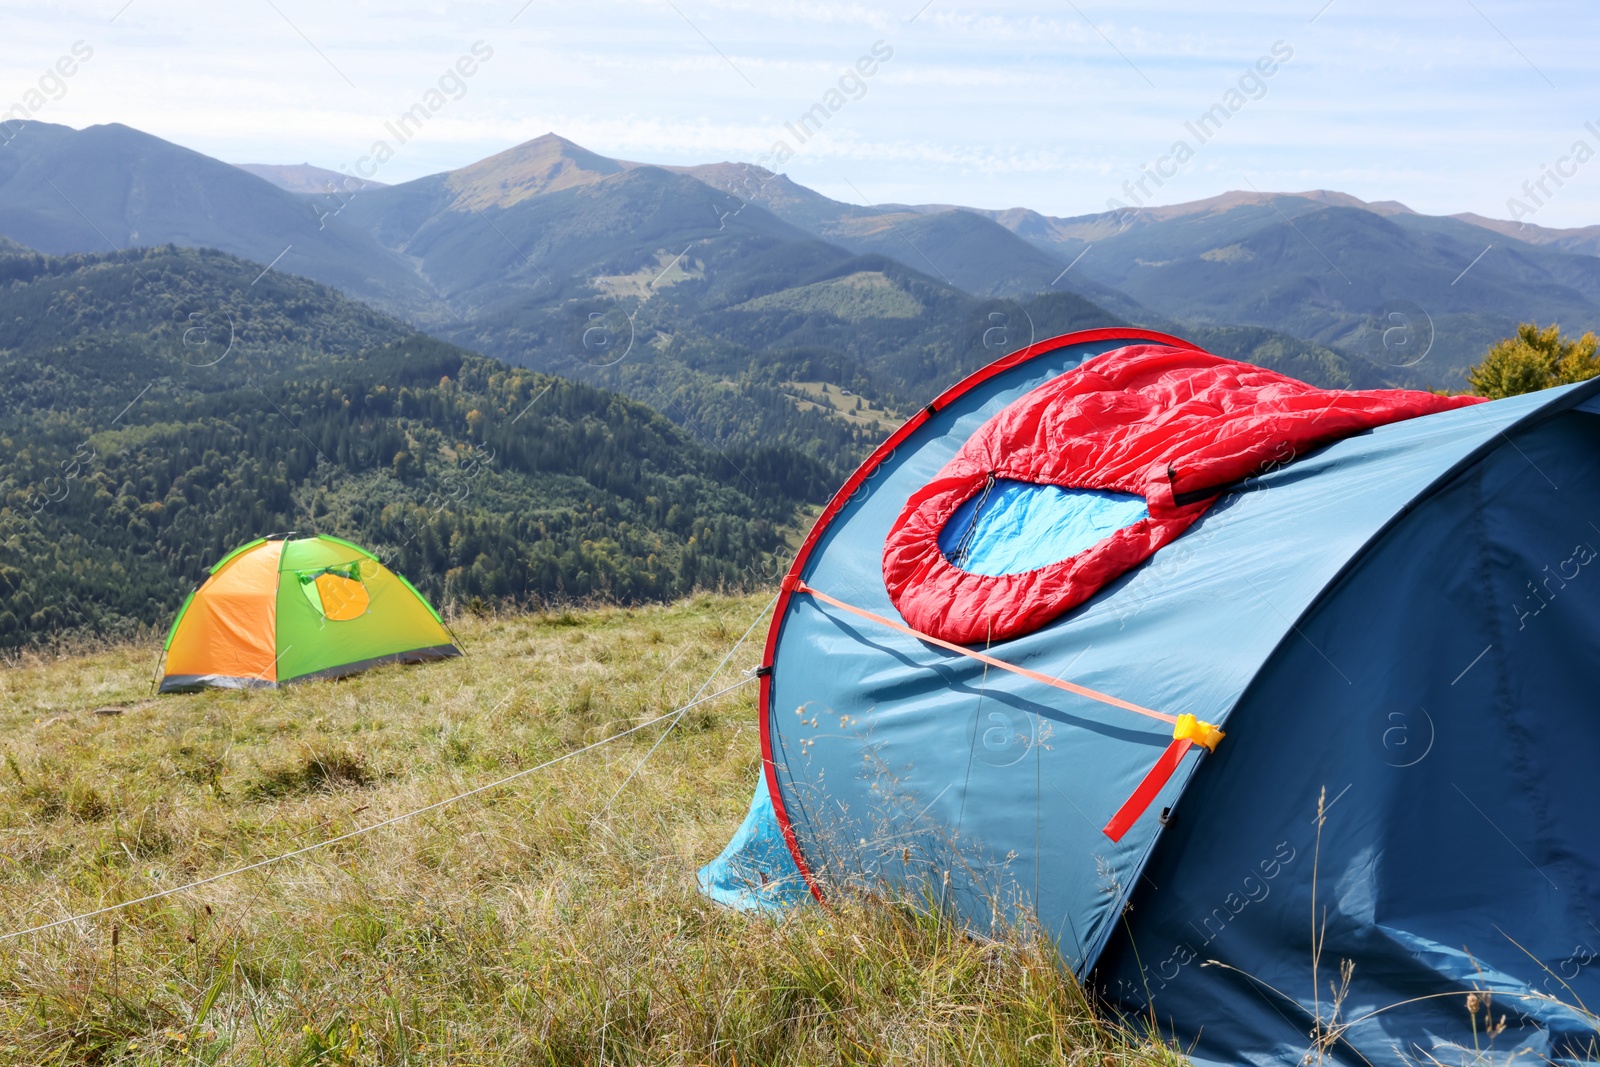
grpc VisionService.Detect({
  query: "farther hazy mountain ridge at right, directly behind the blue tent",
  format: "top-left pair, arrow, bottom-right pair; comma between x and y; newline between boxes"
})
690,165 -> 1600,379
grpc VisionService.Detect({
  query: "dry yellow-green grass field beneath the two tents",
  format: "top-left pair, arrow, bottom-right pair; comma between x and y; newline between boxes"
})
0,597 -> 1176,1065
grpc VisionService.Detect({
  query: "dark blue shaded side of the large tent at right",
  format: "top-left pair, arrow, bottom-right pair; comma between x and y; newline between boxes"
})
1096,395 -> 1600,1064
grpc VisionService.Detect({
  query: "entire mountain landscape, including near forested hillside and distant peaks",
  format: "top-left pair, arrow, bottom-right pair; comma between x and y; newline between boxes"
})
0,122 -> 1600,645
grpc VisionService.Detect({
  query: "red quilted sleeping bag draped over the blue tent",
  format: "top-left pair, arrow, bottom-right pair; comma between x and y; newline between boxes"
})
883,344 -> 1482,645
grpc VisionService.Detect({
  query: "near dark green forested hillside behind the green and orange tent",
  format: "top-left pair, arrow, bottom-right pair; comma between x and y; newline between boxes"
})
0,248 -> 837,645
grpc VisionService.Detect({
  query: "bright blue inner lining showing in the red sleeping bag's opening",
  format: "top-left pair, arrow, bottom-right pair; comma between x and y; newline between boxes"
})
939,478 -> 1150,574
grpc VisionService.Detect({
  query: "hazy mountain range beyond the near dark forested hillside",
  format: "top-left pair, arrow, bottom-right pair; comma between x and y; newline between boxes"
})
0,122 -> 1600,435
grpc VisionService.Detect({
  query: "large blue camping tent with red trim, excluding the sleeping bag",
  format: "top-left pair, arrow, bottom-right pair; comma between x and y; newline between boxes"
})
701,330 -> 1600,1064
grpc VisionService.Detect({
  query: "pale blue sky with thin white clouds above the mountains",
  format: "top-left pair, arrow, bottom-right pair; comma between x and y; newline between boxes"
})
0,0 -> 1600,226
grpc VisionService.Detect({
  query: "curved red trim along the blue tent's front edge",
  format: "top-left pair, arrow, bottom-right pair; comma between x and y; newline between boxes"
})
760,326 -> 1202,901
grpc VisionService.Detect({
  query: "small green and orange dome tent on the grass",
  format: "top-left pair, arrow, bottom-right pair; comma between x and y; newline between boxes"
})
160,534 -> 461,693
